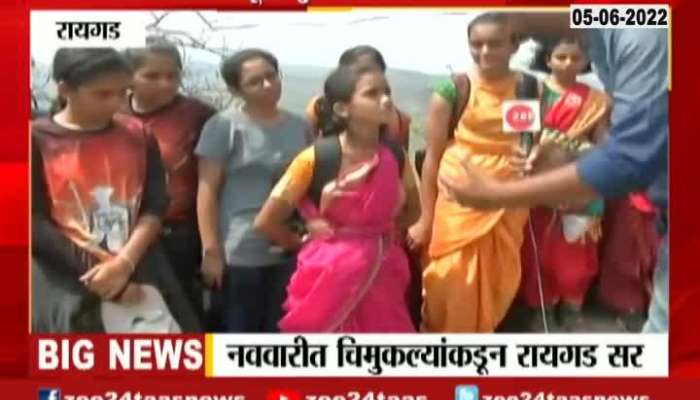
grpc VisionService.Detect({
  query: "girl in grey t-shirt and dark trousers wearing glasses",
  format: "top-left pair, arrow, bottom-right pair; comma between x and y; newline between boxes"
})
195,49 -> 311,332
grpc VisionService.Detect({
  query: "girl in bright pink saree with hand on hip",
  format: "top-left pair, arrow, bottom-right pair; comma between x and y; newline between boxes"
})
255,69 -> 419,332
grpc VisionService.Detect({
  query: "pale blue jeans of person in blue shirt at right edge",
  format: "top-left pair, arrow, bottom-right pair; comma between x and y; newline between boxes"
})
642,235 -> 668,333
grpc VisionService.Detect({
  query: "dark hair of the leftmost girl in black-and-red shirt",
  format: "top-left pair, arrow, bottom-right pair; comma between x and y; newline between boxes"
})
51,47 -> 132,114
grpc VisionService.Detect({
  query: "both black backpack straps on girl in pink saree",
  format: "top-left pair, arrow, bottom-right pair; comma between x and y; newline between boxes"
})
309,135 -> 406,205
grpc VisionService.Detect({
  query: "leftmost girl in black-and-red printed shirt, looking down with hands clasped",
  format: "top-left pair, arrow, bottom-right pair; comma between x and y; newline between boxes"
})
31,48 -> 199,332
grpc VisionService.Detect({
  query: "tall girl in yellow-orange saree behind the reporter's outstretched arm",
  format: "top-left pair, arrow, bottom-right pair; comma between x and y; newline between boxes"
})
409,13 -> 528,332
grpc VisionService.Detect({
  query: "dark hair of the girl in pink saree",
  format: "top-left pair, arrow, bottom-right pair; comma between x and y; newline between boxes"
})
315,66 -> 386,137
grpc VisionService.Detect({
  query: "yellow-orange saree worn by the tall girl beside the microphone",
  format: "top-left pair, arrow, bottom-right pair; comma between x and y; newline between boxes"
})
422,74 -> 528,332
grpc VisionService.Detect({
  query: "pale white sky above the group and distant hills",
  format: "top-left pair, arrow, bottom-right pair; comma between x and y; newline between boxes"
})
31,9 -> 534,74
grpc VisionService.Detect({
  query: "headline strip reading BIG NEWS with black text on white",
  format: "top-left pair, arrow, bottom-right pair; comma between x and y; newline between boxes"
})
33,334 -> 668,378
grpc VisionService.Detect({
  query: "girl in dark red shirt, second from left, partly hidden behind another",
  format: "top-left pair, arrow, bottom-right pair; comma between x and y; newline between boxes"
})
122,39 -> 216,322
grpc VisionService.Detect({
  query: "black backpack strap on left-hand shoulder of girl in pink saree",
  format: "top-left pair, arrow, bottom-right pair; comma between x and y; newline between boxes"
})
309,136 -> 343,205
